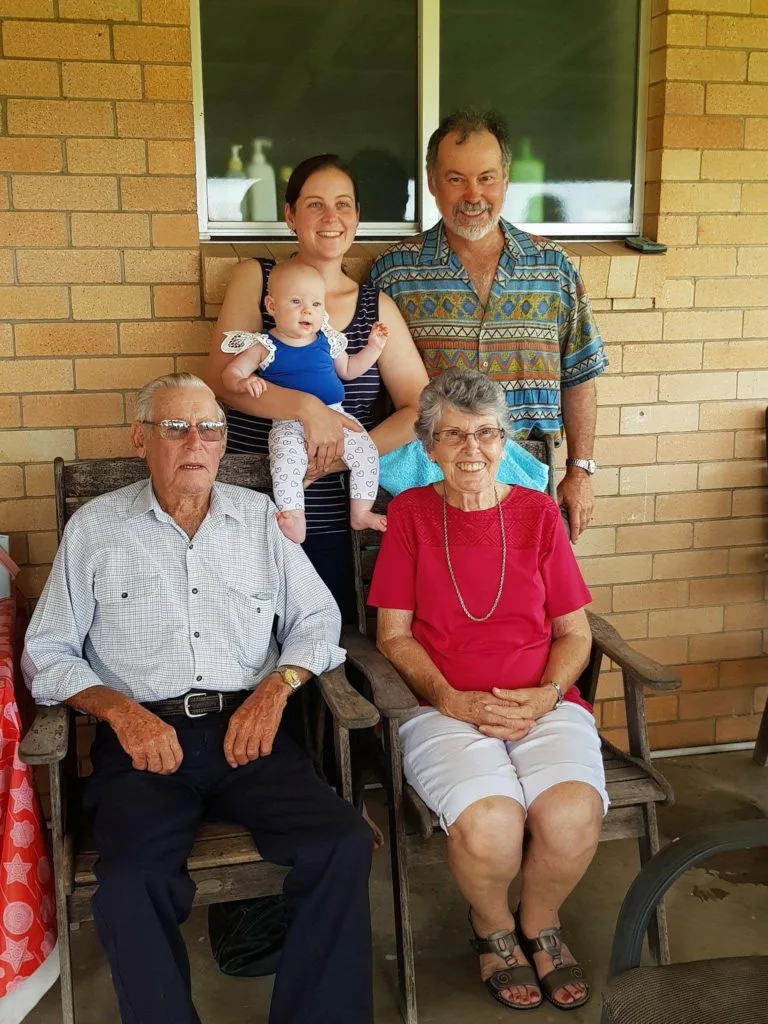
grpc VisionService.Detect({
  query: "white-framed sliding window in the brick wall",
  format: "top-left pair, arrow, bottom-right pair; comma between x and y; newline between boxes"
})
193,0 -> 649,238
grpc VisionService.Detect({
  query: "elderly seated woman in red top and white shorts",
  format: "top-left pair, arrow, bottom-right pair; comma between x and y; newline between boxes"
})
370,370 -> 608,1010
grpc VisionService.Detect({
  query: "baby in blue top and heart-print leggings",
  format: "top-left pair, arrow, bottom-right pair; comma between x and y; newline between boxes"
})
221,260 -> 388,544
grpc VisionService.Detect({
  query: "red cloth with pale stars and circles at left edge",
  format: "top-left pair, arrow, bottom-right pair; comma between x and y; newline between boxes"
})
0,597 -> 56,999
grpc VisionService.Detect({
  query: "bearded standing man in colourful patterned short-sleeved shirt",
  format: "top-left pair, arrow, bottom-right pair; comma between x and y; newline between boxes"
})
371,111 -> 607,541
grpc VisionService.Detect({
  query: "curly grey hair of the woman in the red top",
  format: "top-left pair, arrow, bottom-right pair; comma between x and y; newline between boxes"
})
415,370 -> 512,452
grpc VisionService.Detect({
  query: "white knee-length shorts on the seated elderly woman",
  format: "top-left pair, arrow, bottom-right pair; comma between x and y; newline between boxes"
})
400,700 -> 608,831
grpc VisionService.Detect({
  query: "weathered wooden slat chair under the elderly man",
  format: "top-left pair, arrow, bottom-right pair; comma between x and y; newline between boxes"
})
20,455 -> 379,1024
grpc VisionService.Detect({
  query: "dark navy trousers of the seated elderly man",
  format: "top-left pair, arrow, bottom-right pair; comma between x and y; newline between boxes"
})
85,714 -> 373,1024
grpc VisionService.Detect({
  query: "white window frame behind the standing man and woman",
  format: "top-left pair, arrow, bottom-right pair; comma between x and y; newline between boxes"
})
189,0 -> 652,242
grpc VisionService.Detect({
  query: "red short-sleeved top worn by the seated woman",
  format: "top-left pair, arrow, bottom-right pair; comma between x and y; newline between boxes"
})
369,485 -> 591,708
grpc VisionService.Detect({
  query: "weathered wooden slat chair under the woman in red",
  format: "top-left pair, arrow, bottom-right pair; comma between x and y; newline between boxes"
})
342,440 -> 680,1024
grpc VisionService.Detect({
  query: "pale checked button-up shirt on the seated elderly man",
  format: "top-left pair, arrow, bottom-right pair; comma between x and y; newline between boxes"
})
22,480 -> 345,705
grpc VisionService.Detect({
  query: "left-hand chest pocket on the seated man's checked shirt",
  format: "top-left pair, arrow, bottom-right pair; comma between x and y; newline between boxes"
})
93,572 -> 167,654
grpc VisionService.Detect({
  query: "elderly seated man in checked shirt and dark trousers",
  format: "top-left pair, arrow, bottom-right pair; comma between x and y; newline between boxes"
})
24,374 -> 373,1024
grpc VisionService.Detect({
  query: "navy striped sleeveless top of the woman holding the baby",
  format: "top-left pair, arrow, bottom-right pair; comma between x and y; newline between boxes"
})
226,259 -> 381,534
